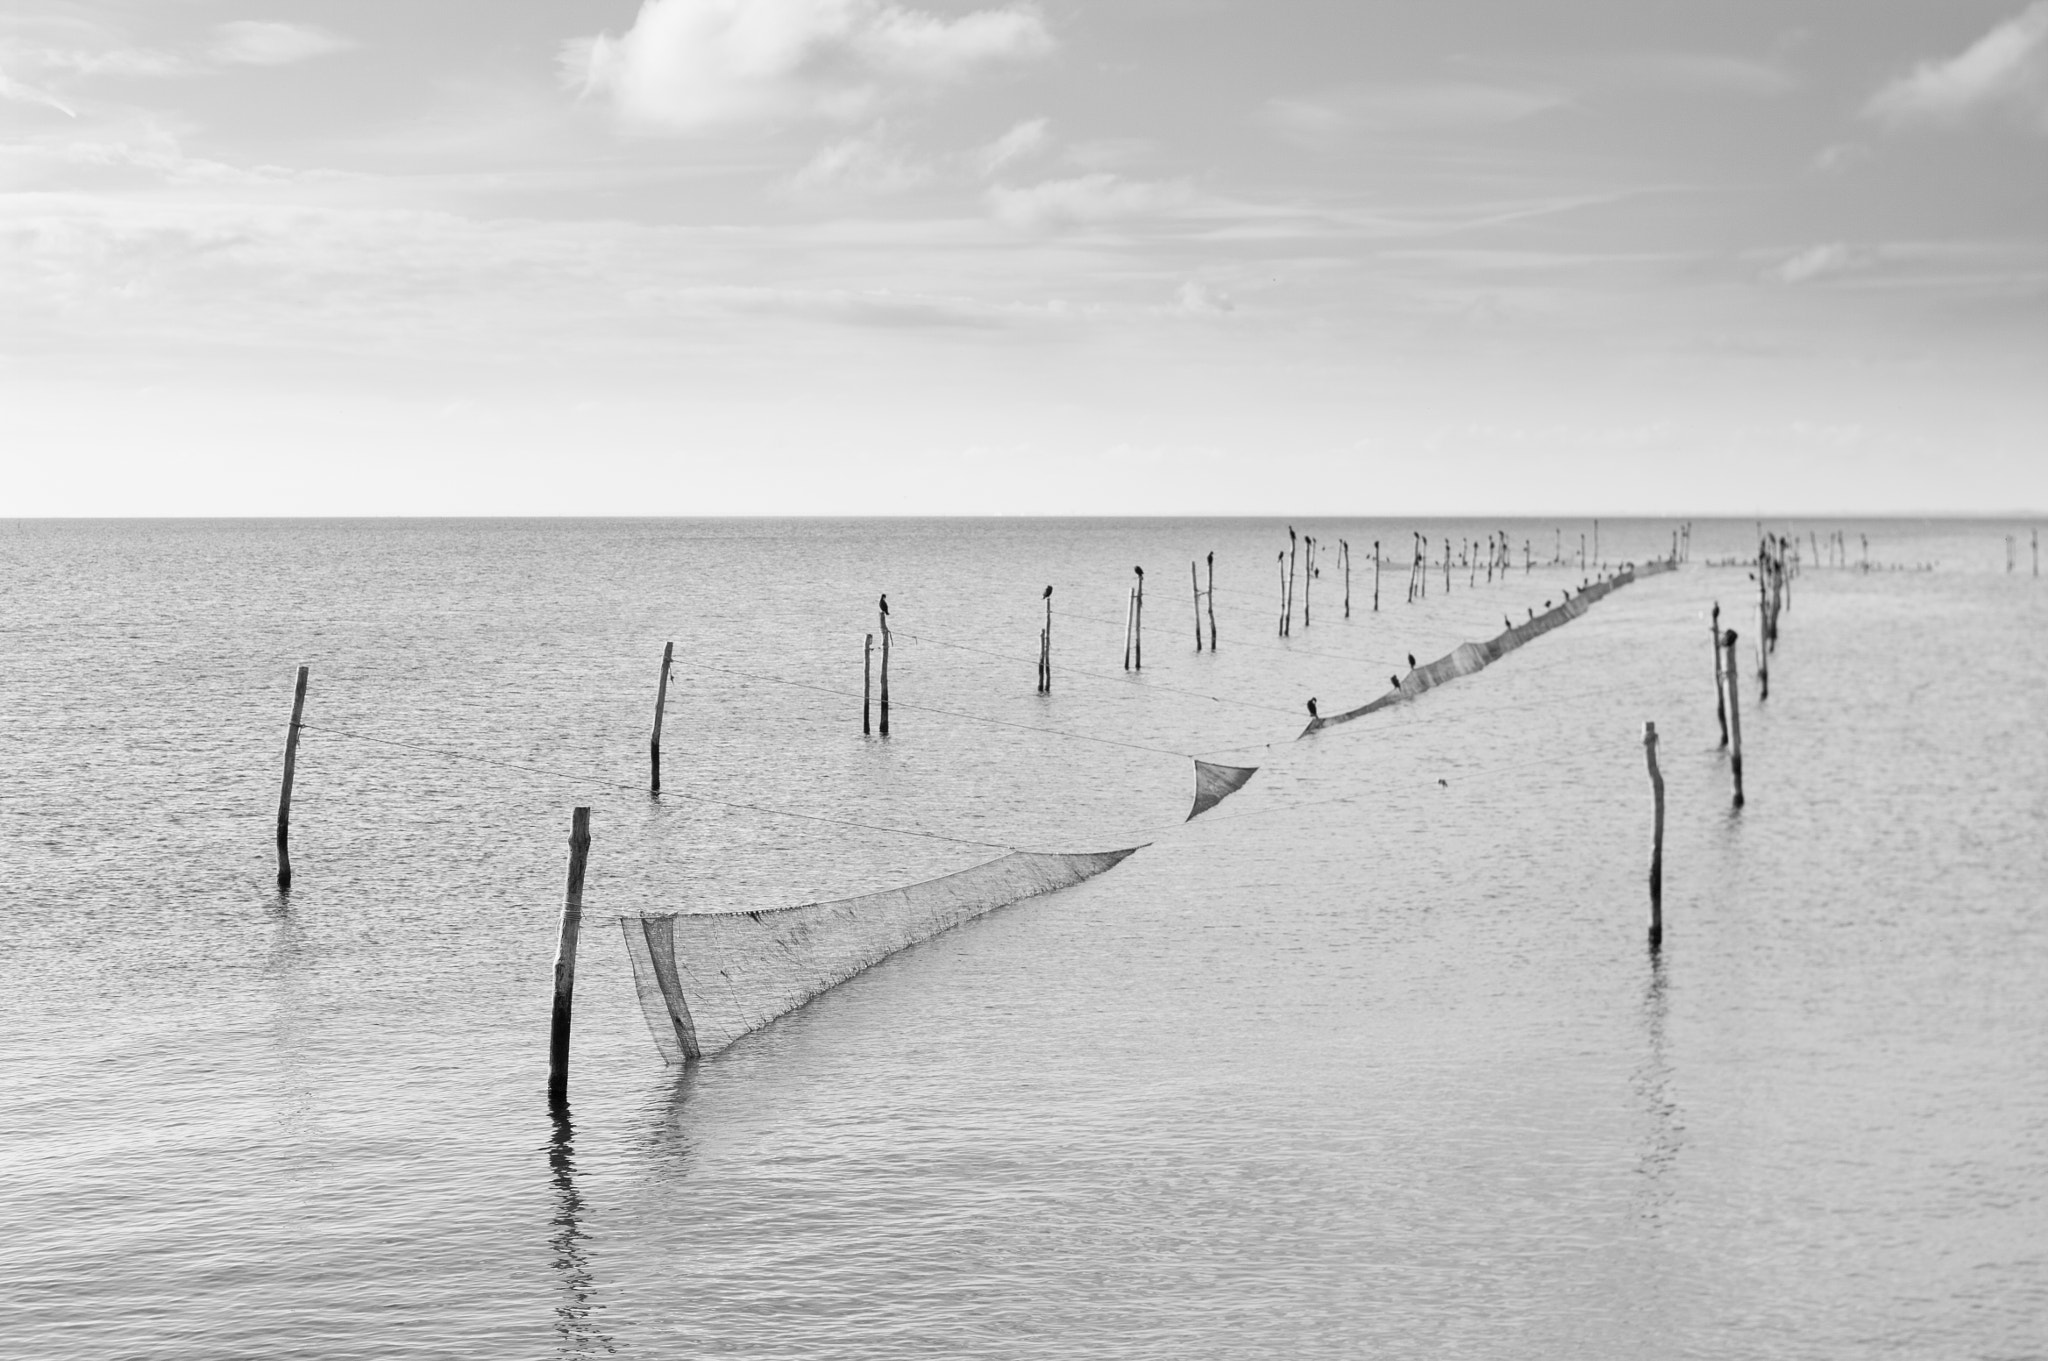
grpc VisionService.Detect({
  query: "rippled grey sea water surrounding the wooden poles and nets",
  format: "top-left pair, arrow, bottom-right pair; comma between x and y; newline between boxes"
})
0,522 -> 2048,1359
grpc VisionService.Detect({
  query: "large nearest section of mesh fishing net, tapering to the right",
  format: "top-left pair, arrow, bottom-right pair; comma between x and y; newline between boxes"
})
618,845 -> 1139,1064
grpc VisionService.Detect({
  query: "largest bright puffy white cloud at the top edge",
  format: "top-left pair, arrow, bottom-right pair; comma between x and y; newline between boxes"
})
563,0 -> 1053,131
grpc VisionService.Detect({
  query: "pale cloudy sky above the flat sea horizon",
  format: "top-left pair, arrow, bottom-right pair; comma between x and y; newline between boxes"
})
0,0 -> 2048,516
